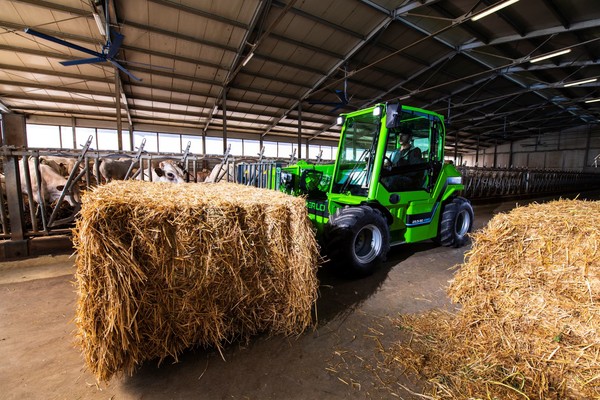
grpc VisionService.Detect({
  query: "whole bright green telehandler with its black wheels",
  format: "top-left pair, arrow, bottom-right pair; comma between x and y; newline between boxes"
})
278,103 -> 474,277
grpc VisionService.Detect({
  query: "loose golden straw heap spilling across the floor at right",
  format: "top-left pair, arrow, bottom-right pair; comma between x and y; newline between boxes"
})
383,200 -> 600,399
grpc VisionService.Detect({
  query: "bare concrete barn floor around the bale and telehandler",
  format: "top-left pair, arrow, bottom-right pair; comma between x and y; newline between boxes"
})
0,194 -> 596,399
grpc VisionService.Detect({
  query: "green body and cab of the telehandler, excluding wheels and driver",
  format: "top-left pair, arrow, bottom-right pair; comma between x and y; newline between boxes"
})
280,104 -> 464,244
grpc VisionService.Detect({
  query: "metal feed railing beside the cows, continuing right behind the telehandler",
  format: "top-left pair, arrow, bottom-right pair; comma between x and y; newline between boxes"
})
0,152 -> 600,258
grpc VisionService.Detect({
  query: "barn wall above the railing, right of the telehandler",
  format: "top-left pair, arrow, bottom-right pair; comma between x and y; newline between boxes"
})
462,126 -> 600,171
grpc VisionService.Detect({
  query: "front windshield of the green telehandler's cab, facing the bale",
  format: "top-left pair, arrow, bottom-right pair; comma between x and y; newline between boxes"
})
332,112 -> 380,196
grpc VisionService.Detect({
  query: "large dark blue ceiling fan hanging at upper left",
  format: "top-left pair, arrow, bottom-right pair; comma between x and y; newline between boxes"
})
25,0 -> 142,82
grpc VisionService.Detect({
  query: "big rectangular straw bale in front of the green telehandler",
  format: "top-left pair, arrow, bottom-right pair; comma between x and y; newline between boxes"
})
74,181 -> 318,381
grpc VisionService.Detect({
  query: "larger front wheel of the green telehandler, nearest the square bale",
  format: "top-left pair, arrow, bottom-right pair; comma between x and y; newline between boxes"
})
324,206 -> 390,277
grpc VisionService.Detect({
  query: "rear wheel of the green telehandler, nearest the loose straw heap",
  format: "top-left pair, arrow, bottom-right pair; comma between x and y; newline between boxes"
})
438,197 -> 475,247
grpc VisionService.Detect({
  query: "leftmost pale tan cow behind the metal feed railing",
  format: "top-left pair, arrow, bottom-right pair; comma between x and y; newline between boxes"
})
21,160 -> 80,207
